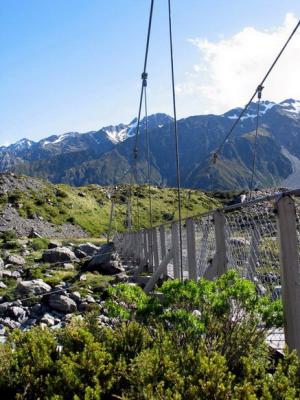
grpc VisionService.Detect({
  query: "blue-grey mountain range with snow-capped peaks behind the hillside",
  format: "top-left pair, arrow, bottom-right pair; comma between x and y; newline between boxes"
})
0,99 -> 300,189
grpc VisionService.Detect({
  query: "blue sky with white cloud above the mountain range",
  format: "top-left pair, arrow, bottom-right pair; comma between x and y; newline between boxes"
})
0,0 -> 300,144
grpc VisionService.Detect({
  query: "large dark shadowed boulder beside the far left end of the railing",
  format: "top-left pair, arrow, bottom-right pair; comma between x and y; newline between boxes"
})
85,242 -> 124,275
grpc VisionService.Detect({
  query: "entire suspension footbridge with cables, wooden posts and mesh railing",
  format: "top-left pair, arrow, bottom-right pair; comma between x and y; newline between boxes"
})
106,0 -> 300,354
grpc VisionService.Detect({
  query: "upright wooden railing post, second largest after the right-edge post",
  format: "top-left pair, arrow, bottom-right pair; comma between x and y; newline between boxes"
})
213,210 -> 227,277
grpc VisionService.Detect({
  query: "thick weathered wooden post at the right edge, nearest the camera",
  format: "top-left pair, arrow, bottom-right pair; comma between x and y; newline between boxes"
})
277,196 -> 300,355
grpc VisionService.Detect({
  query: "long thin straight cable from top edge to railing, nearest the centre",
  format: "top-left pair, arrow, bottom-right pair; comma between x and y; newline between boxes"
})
168,0 -> 183,280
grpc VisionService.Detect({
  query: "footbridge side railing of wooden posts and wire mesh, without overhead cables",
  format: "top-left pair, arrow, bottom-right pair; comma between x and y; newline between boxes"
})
114,190 -> 300,352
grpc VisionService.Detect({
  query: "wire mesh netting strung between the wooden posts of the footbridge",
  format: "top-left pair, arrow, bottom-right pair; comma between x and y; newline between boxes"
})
115,191 -> 300,299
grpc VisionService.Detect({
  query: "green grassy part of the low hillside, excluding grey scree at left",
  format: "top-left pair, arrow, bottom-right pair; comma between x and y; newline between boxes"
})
0,176 -> 219,236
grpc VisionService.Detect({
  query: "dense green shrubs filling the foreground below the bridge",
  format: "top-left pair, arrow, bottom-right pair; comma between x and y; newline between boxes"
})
0,271 -> 300,400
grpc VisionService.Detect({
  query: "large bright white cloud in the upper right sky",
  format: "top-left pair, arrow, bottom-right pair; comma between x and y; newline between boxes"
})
176,13 -> 300,114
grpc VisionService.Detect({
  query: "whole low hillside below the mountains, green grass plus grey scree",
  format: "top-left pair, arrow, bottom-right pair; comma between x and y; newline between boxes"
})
0,173 -> 218,238
